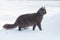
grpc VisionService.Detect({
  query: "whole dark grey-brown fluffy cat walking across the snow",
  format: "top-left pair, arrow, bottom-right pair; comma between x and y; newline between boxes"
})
3,7 -> 46,31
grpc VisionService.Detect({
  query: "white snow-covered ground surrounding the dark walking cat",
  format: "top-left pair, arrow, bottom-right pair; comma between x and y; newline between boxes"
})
0,0 -> 60,40
